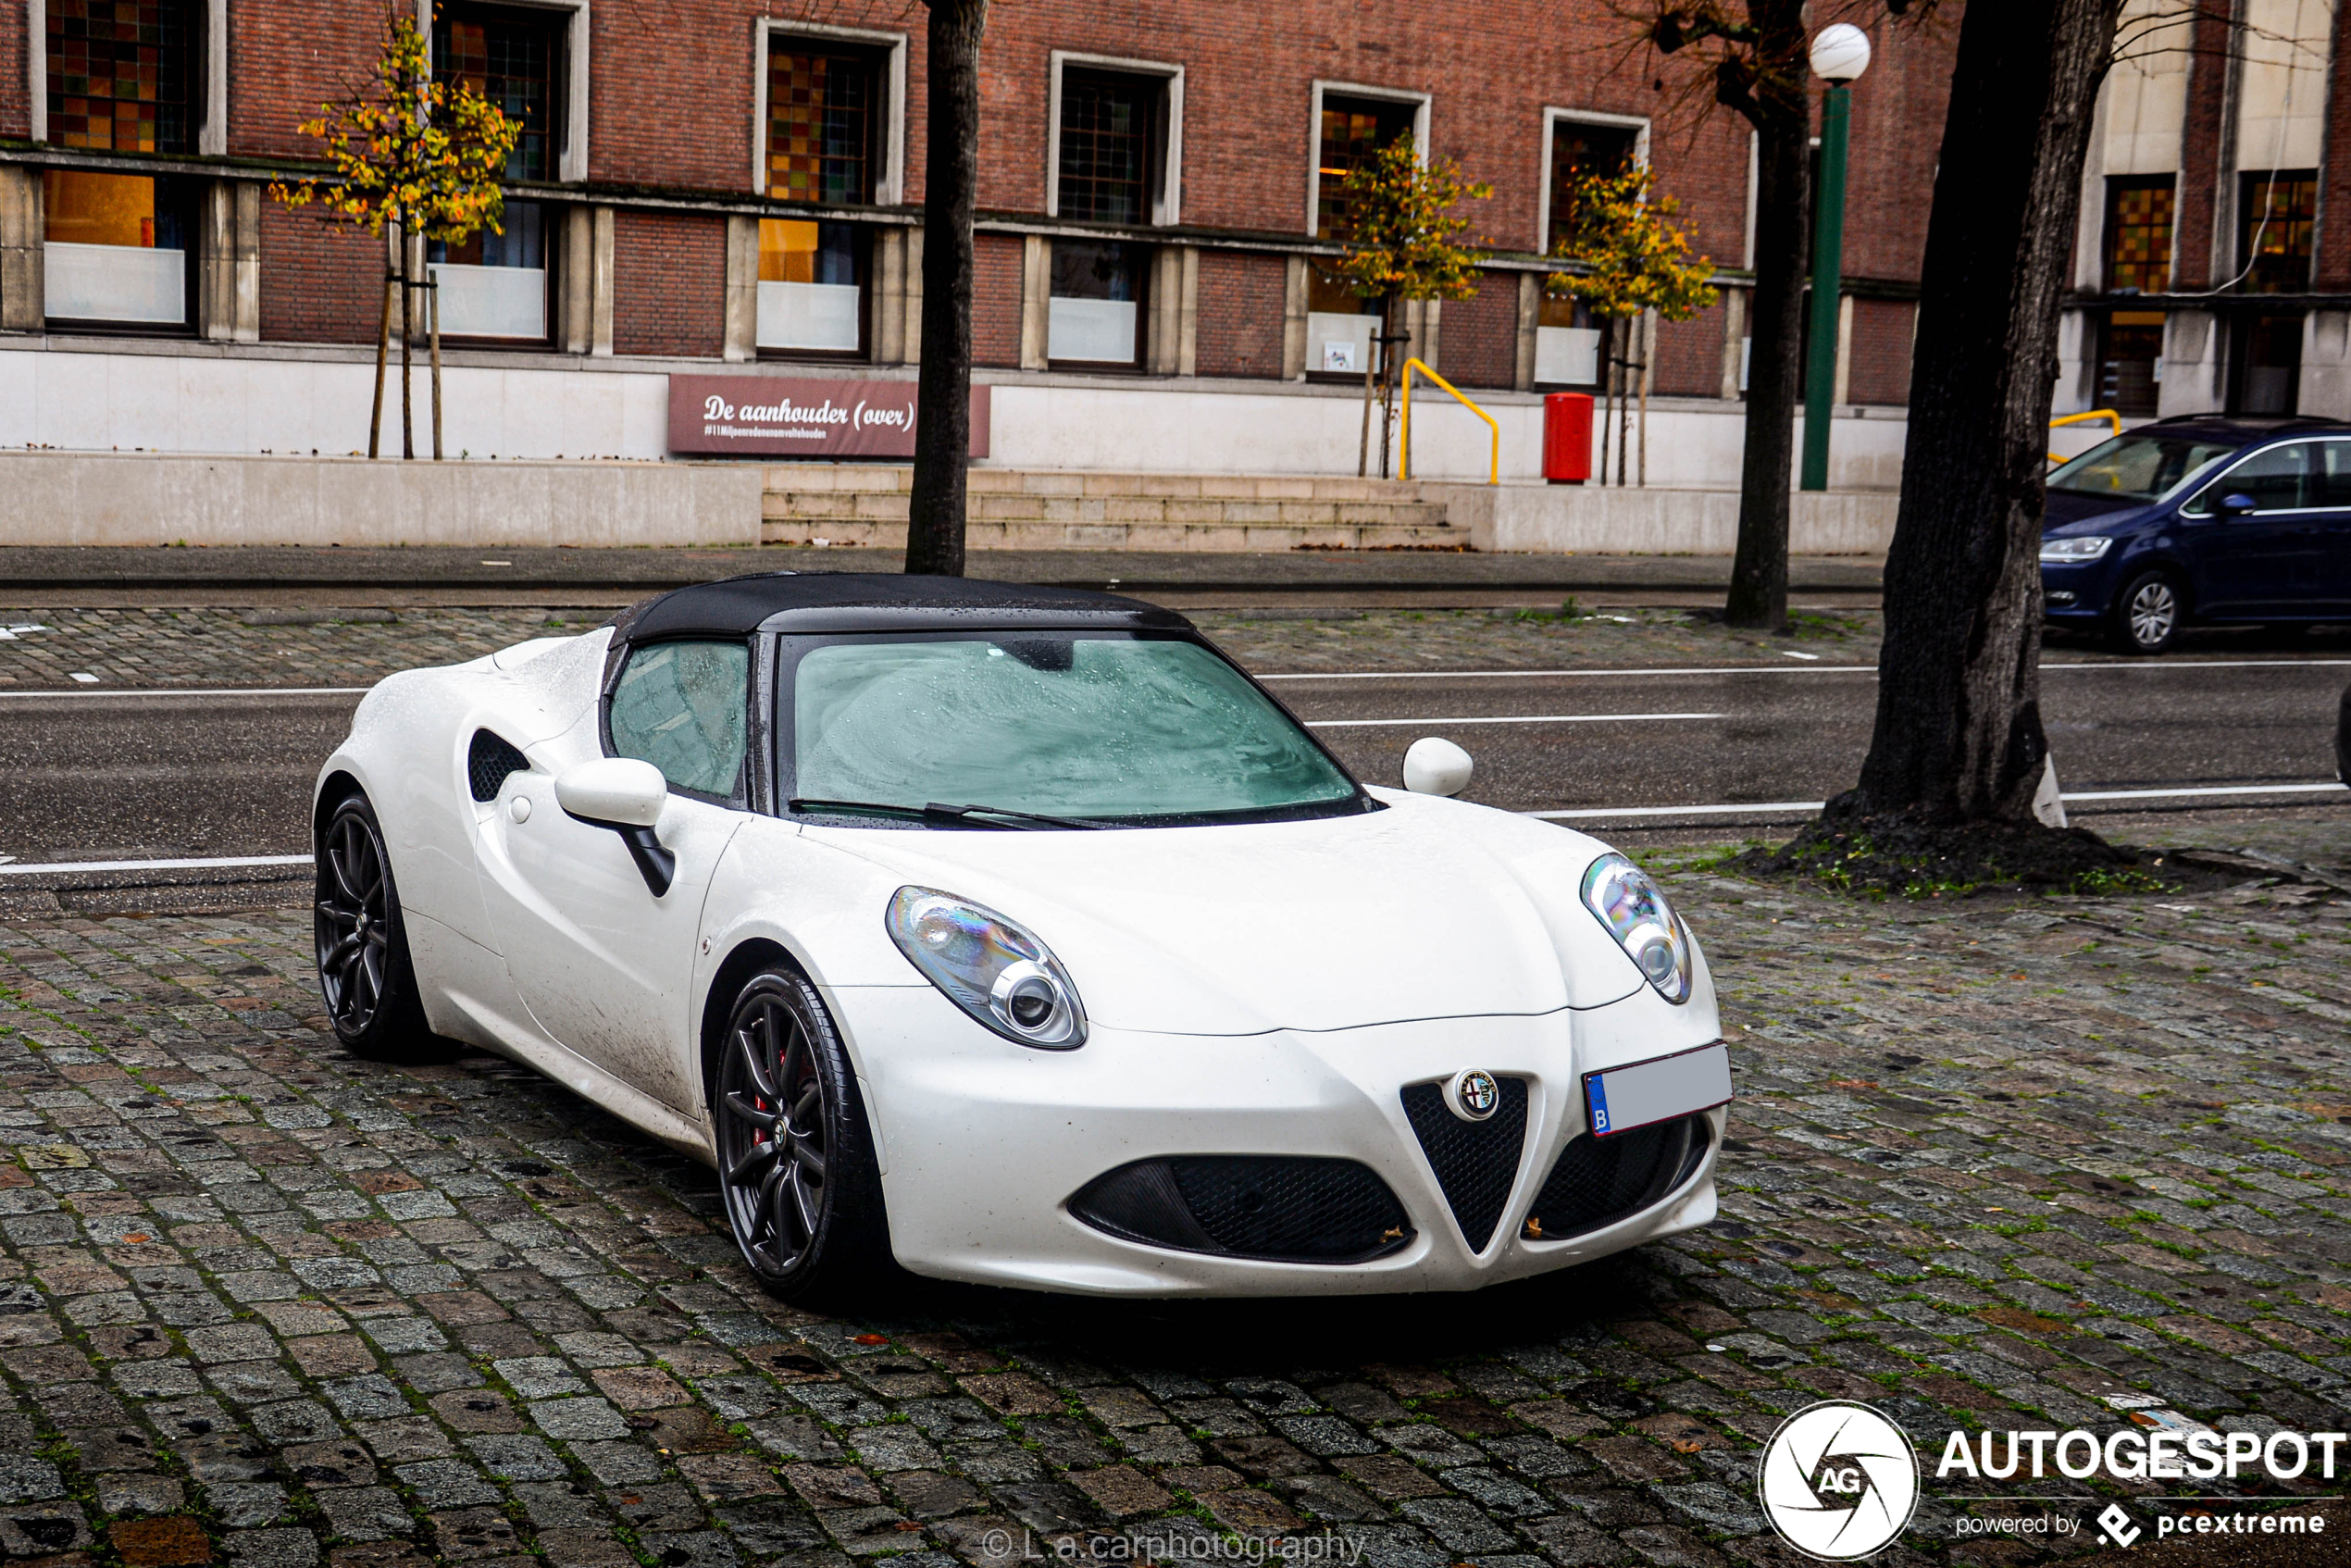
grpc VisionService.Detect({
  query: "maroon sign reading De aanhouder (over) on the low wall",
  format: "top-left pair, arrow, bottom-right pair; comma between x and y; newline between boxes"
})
670,376 -> 988,458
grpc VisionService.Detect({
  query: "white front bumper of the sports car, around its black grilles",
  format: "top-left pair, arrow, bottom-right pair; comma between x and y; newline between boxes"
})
830,988 -> 1723,1295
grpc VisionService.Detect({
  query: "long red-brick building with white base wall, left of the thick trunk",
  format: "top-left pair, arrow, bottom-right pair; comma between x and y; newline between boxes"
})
0,0 -> 1947,484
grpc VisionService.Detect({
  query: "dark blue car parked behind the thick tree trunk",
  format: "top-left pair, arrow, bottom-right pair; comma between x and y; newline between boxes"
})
2041,414 -> 2351,653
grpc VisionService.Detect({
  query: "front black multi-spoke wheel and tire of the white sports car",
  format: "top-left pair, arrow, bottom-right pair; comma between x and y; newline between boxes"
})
710,966 -> 893,1300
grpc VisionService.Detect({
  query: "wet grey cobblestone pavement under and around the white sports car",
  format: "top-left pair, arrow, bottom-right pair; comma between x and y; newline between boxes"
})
0,825 -> 2351,1568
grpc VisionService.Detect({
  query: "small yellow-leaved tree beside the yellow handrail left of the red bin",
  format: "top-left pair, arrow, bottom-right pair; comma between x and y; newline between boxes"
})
1331,134 -> 1493,478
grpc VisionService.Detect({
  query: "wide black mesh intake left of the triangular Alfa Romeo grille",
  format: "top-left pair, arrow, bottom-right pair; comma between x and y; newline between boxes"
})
1070,1154 -> 1413,1263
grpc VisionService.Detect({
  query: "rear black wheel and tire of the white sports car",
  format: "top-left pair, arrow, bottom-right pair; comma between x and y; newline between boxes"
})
310,792 -> 435,1060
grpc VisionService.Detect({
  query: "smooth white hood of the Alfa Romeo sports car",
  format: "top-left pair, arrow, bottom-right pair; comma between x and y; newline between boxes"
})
806,790 -> 1664,1034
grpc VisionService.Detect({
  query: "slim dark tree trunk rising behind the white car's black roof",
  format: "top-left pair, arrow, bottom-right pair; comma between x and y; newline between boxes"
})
905,0 -> 988,576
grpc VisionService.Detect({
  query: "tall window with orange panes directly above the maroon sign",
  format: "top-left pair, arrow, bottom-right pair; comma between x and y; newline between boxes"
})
753,38 -> 887,355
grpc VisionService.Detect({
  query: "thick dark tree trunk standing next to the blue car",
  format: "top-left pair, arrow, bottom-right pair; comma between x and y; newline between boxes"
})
1836,0 -> 2119,823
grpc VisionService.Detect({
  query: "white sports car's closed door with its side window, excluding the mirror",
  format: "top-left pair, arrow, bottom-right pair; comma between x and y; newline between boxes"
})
482,640 -> 750,1110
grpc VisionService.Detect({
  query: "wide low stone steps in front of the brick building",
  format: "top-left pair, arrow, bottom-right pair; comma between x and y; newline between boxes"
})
759,463 -> 1470,553
